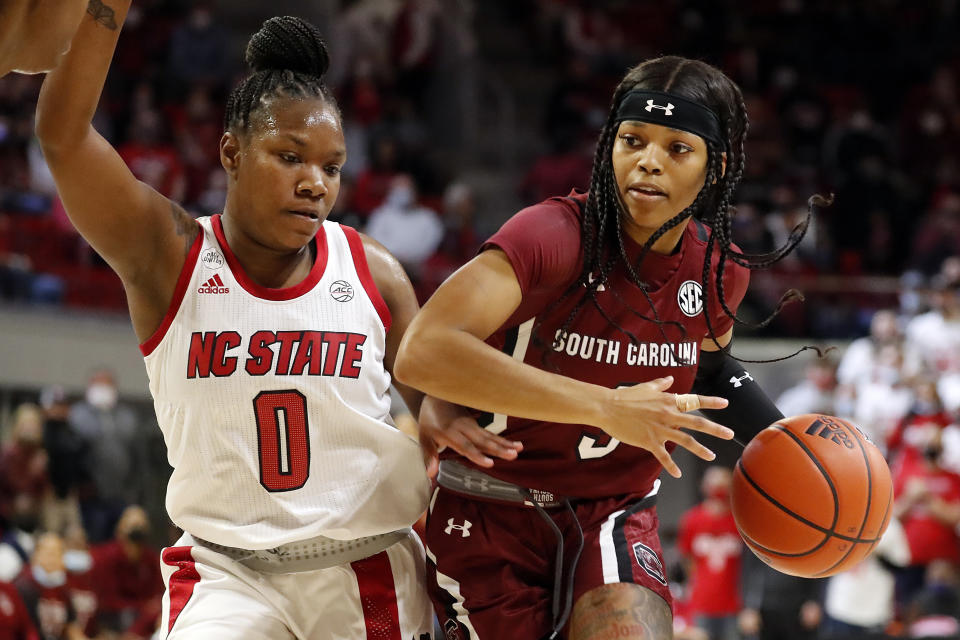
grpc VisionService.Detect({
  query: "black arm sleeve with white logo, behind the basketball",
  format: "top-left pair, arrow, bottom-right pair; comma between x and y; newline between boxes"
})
693,344 -> 783,444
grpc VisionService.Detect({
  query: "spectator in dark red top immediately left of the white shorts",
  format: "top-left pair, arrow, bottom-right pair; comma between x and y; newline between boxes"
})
91,505 -> 163,638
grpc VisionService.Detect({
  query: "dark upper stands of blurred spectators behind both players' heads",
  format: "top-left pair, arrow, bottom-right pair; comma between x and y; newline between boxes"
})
0,0 -> 960,338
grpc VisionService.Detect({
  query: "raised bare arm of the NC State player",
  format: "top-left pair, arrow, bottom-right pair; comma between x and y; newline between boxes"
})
36,0 -> 198,340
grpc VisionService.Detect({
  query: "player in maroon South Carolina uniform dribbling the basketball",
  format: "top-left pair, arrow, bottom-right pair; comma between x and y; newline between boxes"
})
396,56 -> 802,640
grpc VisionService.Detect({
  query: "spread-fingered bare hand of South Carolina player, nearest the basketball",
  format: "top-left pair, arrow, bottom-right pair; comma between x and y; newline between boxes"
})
596,376 -> 734,478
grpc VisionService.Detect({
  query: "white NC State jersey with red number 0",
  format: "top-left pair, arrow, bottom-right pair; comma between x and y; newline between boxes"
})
141,216 -> 429,549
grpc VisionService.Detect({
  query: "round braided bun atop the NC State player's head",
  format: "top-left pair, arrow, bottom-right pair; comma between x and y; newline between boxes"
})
246,16 -> 330,78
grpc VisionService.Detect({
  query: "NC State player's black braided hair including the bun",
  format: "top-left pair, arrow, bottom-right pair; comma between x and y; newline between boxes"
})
224,16 -> 339,134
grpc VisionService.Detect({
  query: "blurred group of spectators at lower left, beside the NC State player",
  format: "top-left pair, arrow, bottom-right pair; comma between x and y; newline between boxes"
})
0,370 -> 167,640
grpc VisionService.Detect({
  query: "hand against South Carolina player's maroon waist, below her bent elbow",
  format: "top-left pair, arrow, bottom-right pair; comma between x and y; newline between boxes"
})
420,396 -> 523,477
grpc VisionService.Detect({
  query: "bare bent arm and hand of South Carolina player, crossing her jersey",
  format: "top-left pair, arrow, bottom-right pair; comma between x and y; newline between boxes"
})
395,249 -> 732,477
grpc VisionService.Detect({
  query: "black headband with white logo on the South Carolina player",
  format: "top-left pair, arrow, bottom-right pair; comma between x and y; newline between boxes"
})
614,89 -> 727,148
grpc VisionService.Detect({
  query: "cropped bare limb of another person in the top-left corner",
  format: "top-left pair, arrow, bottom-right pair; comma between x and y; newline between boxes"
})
0,0 -> 86,77
